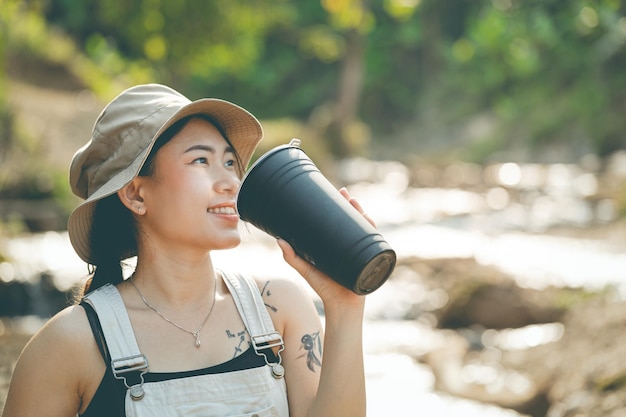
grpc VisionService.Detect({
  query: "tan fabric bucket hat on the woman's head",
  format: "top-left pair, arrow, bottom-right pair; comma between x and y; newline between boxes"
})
67,84 -> 263,263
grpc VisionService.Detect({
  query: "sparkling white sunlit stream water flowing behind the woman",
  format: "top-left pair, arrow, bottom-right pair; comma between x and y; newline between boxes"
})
0,156 -> 626,417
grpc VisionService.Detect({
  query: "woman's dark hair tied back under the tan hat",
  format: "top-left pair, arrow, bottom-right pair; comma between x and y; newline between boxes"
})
82,114 -> 241,295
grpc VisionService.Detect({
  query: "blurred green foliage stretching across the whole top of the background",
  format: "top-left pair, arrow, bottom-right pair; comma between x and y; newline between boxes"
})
0,0 -> 626,160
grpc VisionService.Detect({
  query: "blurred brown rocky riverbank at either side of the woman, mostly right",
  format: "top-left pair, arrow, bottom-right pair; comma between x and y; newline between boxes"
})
0,245 -> 626,417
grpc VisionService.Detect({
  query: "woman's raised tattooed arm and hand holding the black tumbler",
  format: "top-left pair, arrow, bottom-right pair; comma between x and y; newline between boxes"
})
278,188 -> 374,417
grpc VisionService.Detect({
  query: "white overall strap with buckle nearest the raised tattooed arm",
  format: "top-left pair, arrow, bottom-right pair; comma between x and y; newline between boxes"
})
220,271 -> 285,378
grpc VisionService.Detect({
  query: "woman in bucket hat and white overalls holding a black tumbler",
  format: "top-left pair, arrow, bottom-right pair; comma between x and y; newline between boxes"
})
2,84 -> 365,417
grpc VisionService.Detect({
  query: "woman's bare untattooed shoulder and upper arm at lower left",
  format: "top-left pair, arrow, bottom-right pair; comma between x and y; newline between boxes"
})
2,306 -> 104,417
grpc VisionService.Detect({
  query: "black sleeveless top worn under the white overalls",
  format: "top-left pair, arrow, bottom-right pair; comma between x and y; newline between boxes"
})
81,302 -> 277,417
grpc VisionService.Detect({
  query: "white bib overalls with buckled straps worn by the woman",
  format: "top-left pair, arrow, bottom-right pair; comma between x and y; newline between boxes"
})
85,273 -> 289,417
